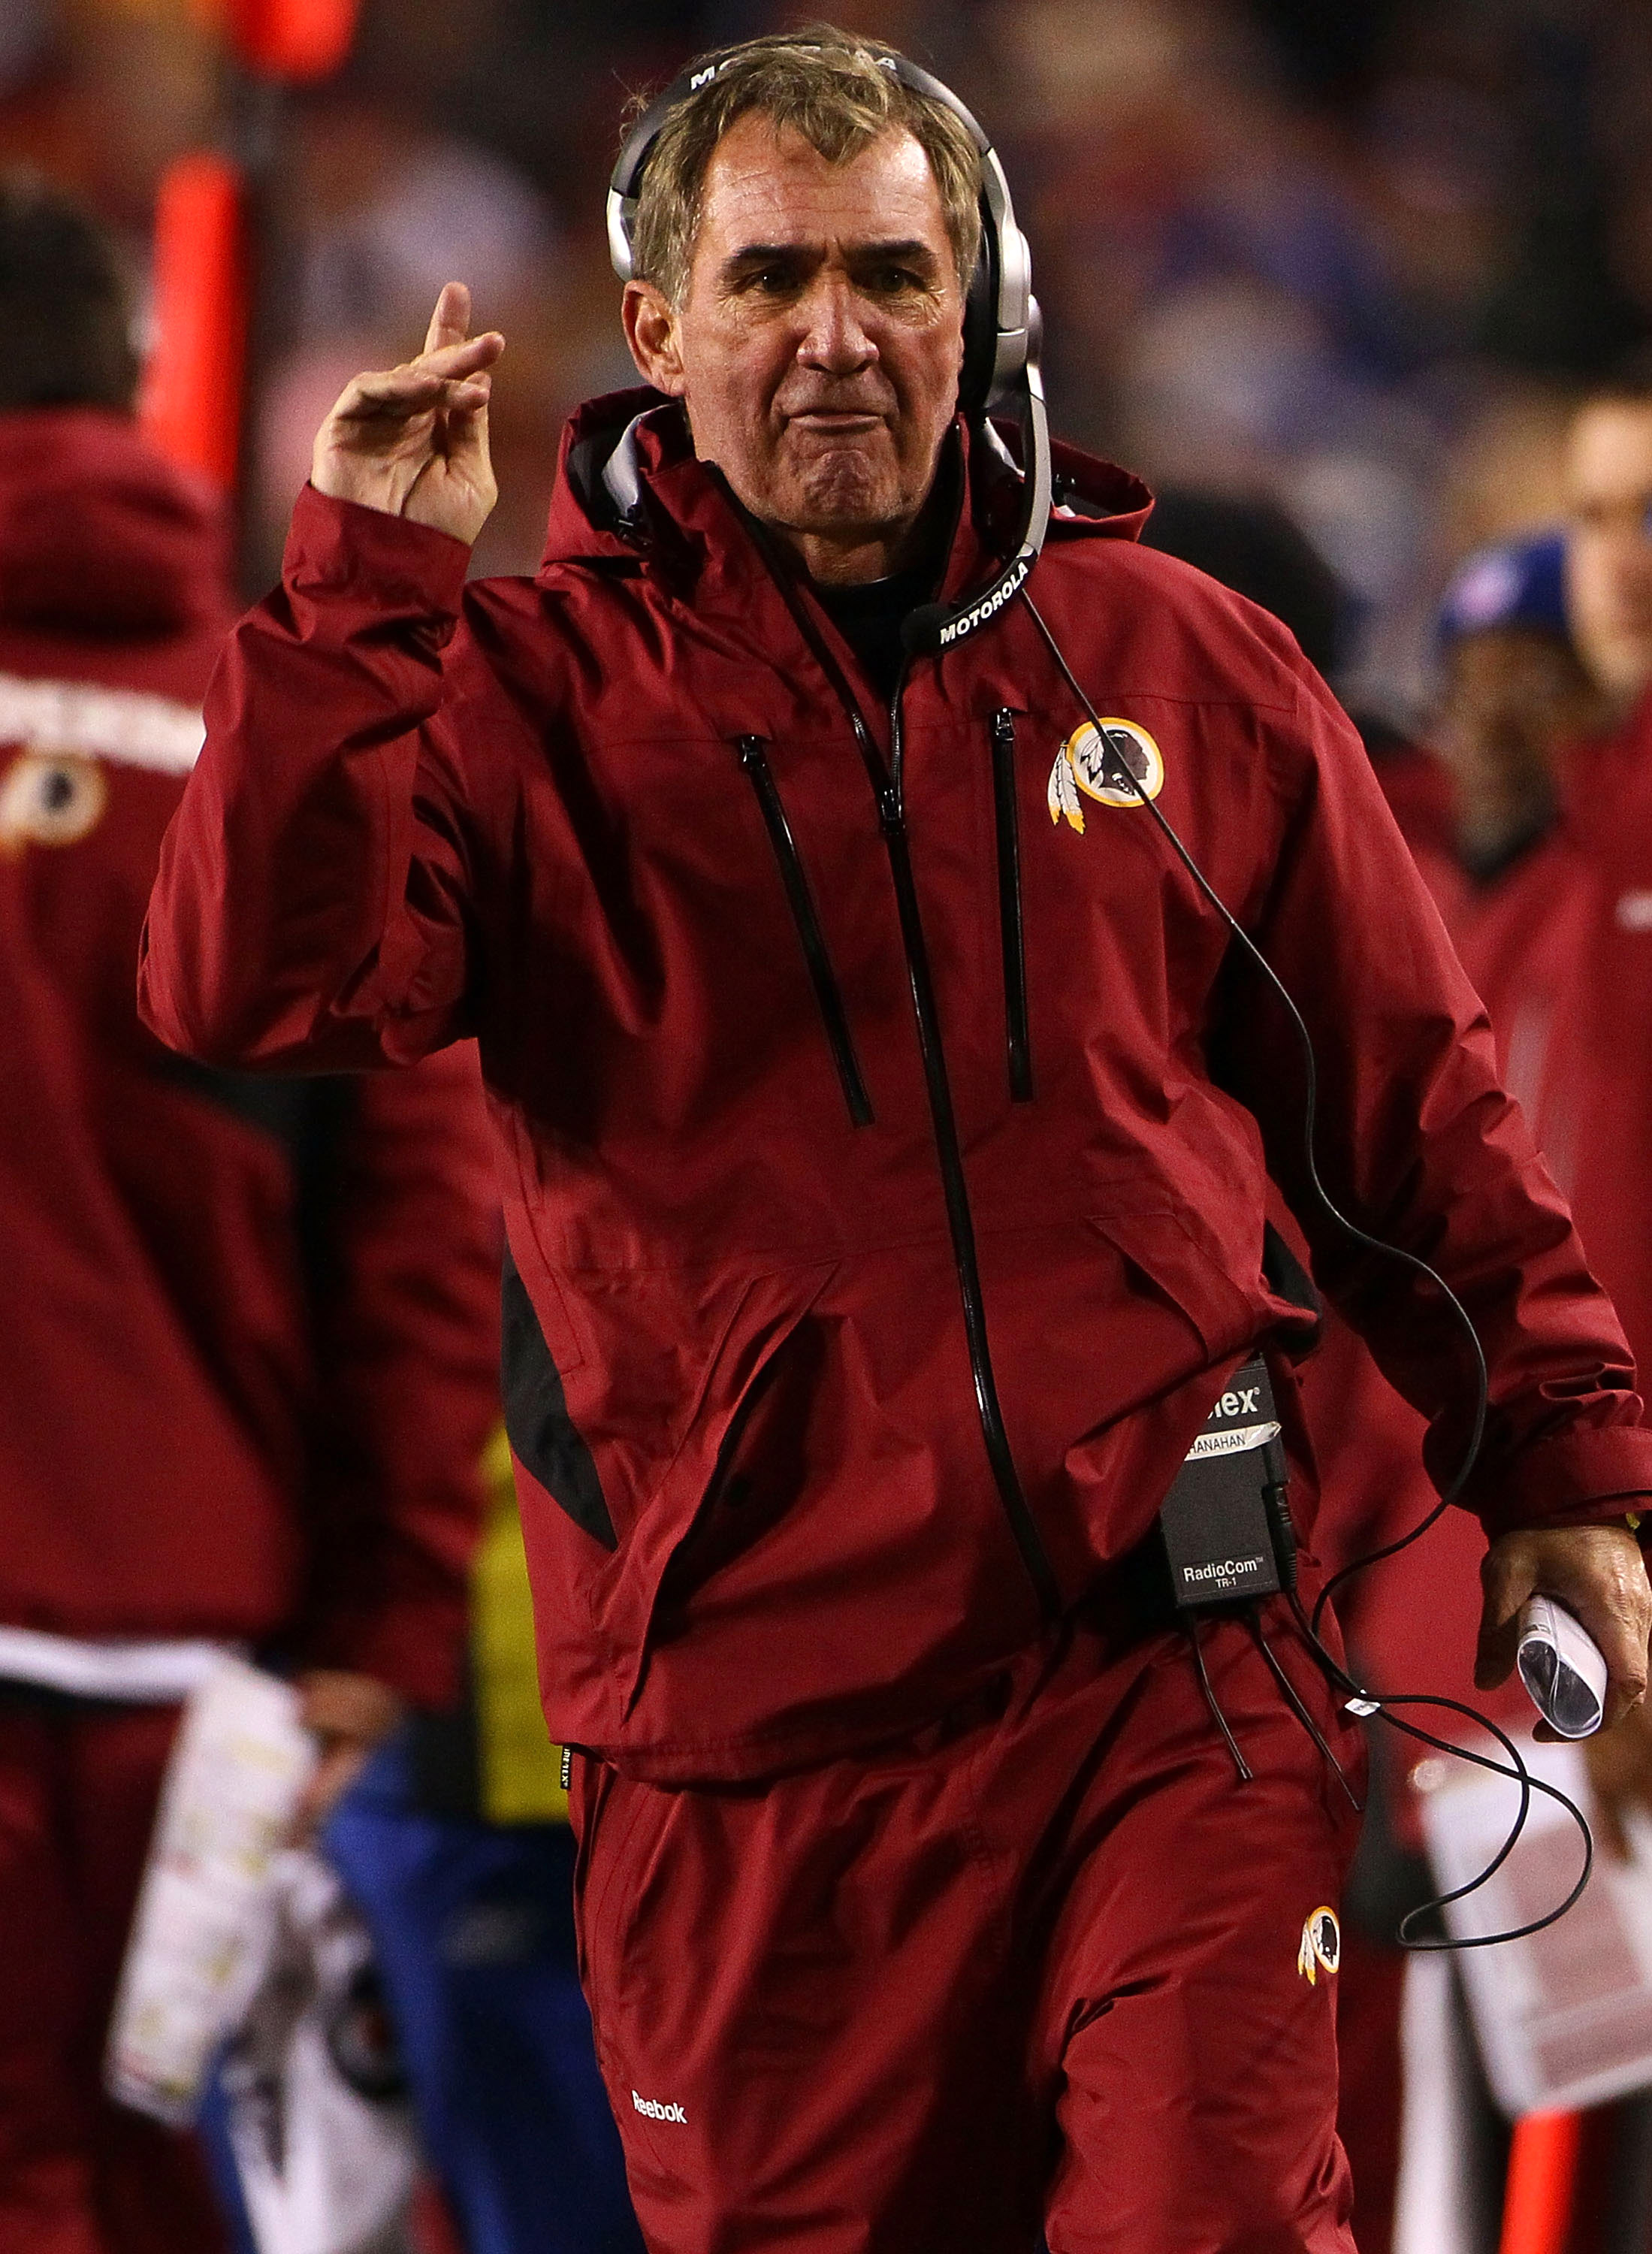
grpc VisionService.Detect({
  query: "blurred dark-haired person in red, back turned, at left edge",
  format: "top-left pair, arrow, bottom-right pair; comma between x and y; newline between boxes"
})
0,180 -> 498,2254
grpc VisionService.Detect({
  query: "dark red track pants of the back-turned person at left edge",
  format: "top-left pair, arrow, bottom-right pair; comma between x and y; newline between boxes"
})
0,1688 -> 225,2254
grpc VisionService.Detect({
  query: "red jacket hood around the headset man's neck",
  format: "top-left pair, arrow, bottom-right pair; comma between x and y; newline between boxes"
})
541,388 -> 1154,570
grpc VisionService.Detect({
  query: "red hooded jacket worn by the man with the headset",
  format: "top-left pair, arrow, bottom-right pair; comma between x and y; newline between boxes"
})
142,394 -> 1652,1776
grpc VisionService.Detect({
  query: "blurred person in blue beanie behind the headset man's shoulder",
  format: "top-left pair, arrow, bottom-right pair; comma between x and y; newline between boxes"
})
1303,532 -> 1600,2254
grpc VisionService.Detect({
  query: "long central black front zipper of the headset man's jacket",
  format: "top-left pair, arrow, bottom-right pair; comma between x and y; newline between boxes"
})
730,532 -> 1062,1621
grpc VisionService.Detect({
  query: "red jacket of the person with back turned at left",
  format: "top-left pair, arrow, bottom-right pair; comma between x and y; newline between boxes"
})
0,408 -> 496,1697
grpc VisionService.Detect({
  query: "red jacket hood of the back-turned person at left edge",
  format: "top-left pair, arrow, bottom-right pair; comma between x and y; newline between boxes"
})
0,408 -> 230,633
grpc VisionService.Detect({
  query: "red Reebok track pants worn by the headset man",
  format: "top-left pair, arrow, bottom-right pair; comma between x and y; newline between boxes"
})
575,1605 -> 1364,2254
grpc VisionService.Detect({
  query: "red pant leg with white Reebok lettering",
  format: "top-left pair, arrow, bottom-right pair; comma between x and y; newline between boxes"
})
570,1718 -> 1041,2254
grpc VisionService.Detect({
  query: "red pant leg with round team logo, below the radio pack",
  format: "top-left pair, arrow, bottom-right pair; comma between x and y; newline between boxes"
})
1019,1607 -> 1364,2254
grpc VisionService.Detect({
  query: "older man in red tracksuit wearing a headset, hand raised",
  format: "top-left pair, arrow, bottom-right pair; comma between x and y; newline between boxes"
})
144,32 -> 1652,2254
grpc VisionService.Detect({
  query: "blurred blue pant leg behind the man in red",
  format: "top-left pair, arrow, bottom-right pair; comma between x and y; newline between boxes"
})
327,1749 -> 642,2254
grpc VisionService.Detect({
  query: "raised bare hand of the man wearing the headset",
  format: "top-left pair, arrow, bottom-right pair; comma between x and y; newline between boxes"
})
311,282 -> 505,543
